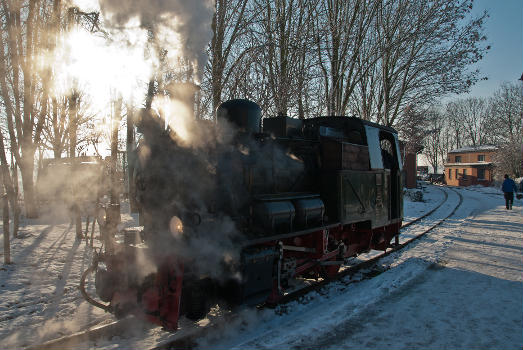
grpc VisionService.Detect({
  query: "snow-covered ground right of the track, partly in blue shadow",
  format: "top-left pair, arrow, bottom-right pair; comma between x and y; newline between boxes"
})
201,185 -> 523,349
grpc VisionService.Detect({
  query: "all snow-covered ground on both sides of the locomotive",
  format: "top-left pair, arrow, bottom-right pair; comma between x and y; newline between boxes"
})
0,186 -> 523,349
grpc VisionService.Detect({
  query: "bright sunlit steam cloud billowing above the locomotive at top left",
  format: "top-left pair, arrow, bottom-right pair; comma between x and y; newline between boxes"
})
40,0 -> 214,117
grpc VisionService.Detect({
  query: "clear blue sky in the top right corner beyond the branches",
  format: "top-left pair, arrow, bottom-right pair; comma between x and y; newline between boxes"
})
458,0 -> 523,97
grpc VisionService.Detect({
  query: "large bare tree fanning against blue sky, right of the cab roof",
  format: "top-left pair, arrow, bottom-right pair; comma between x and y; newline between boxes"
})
360,0 -> 488,125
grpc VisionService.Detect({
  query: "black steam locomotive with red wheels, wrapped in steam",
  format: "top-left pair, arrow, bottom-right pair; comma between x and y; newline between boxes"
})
88,100 -> 403,330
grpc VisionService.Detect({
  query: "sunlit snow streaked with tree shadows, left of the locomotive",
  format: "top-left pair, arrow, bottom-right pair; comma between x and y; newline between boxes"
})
0,202 -> 134,347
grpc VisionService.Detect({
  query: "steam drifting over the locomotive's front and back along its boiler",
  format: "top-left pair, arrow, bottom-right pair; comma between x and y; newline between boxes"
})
137,102 -> 304,280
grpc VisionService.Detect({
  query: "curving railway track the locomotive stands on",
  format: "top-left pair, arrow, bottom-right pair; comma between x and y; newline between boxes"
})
25,187 -> 463,350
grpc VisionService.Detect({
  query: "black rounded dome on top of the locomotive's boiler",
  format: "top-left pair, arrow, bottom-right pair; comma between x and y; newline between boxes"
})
216,99 -> 261,134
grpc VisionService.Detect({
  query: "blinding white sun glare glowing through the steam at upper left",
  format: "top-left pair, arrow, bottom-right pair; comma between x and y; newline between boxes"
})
54,22 -> 153,110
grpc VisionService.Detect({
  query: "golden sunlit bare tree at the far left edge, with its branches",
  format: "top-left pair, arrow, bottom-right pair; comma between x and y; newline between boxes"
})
0,0 -> 105,217
